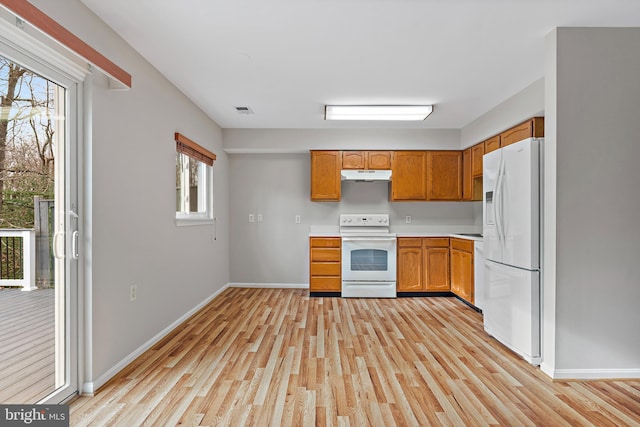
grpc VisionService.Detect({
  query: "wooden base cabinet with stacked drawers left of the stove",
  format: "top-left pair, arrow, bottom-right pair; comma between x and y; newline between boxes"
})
309,237 -> 342,292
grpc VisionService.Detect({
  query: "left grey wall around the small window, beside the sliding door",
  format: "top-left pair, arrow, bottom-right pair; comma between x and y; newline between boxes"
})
32,0 -> 229,388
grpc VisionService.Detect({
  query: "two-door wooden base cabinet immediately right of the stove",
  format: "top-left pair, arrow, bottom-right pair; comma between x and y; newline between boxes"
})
397,237 -> 449,292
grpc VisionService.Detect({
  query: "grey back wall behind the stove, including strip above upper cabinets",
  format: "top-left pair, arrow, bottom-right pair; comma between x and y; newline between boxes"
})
228,129 -> 482,285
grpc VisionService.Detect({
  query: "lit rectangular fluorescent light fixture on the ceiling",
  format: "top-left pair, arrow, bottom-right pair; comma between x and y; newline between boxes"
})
324,105 -> 433,120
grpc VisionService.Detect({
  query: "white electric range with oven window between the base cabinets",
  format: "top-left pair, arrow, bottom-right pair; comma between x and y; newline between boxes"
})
340,214 -> 396,298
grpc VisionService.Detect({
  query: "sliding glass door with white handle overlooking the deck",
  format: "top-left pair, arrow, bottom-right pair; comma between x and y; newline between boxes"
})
0,38 -> 82,404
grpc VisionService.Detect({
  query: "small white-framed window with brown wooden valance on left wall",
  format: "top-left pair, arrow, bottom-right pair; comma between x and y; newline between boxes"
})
175,133 -> 216,225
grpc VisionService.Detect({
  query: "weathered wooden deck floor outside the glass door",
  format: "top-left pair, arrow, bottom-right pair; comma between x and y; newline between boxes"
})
0,289 -> 55,404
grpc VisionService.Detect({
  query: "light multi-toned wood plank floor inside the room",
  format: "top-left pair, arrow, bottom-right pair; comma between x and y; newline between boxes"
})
70,288 -> 640,426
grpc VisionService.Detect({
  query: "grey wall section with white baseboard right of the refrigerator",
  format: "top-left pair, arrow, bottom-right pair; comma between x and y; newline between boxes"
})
544,28 -> 640,378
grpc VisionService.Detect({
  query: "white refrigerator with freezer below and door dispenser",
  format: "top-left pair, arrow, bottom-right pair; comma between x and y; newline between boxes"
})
482,138 -> 542,365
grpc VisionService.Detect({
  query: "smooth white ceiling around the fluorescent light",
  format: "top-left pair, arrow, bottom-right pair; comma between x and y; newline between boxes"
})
82,0 -> 640,129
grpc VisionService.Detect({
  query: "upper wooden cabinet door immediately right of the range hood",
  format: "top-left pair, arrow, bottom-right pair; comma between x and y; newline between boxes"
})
391,151 -> 427,200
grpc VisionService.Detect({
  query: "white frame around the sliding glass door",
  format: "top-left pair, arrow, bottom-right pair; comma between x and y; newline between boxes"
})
0,15 -> 91,404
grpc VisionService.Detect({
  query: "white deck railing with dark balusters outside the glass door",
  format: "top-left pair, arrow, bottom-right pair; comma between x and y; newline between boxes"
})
0,229 -> 36,291
